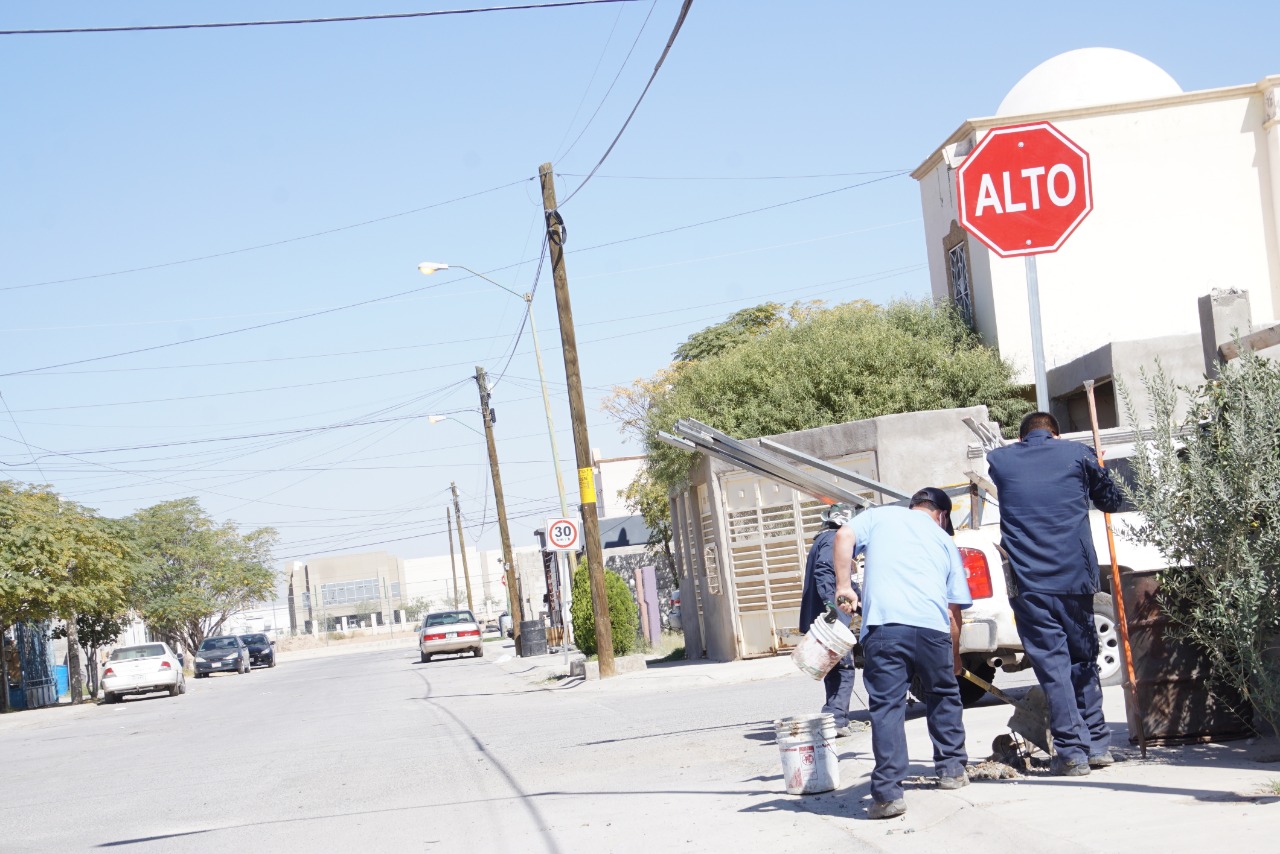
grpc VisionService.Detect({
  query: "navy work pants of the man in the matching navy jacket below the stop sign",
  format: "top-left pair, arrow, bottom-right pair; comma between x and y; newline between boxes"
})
1010,592 -> 1111,762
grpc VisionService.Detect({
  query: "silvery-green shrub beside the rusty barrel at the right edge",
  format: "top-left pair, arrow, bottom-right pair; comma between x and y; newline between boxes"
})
1124,353 -> 1280,731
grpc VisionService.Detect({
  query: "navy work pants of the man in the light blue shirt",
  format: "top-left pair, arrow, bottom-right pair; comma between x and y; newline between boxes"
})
863,624 -> 969,803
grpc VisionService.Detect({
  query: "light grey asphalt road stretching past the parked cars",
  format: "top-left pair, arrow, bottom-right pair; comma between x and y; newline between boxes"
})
0,645 -> 865,853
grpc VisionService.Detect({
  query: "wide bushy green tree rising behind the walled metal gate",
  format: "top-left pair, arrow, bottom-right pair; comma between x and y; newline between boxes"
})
605,301 -> 1030,512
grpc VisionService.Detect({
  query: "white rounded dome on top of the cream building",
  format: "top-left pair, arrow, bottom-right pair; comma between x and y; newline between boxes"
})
996,47 -> 1183,115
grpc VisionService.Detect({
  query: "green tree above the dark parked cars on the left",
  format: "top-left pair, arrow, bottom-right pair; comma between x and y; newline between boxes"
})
129,498 -> 276,649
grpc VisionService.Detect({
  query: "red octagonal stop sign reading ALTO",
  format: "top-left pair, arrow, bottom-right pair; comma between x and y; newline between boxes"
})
956,122 -> 1093,257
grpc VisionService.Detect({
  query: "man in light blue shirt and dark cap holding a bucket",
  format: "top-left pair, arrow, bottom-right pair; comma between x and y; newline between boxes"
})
833,487 -> 973,818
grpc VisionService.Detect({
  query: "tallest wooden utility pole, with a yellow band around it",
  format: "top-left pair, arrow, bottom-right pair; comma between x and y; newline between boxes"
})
538,163 -> 613,679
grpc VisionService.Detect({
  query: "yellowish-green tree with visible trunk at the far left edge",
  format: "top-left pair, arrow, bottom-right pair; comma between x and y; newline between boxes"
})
0,483 -> 133,703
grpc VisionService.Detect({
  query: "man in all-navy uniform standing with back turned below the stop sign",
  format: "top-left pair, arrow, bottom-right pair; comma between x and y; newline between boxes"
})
987,412 -> 1123,777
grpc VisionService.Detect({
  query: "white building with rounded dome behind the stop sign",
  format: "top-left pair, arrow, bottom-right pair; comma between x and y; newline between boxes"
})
913,47 -> 1280,426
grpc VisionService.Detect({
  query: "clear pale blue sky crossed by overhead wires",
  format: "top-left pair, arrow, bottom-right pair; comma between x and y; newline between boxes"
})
0,0 -> 1280,568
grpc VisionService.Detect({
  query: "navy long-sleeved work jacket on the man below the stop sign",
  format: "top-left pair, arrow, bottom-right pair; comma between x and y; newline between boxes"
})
987,430 -> 1121,594
